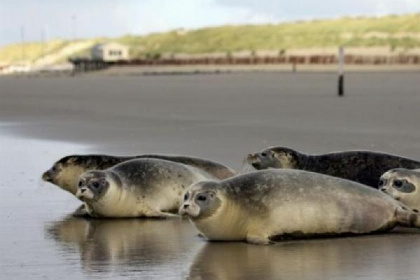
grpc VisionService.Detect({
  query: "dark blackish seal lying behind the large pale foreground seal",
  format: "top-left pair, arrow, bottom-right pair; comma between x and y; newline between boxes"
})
247,147 -> 420,188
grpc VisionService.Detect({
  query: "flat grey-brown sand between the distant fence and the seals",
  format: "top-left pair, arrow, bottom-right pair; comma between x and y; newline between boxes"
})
0,72 -> 420,161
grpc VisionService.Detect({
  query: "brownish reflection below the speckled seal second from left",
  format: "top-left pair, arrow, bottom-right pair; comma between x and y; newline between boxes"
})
46,214 -> 200,273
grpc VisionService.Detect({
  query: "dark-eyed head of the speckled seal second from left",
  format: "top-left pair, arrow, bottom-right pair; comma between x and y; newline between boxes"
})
76,171 -> 113,202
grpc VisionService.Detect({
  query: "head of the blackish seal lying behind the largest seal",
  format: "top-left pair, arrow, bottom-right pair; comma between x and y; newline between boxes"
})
247,147 -> 300,170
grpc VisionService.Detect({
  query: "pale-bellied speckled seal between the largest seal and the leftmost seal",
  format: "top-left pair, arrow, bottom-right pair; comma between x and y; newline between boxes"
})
76,158 -> 215,218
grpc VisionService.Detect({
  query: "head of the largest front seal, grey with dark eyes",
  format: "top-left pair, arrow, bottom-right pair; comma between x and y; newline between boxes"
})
179,181 -> 222,220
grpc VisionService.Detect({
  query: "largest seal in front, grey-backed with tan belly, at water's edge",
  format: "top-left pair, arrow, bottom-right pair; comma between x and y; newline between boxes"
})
179,169 -> 420,244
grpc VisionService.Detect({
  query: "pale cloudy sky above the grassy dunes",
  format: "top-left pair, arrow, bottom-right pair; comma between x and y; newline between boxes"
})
0,0 -> 420,46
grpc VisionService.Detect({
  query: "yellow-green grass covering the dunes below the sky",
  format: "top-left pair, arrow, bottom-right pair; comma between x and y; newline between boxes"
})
0,13 -> 420,62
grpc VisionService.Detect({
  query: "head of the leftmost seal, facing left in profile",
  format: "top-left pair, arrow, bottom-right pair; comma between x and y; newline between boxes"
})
42,155 -> 86,194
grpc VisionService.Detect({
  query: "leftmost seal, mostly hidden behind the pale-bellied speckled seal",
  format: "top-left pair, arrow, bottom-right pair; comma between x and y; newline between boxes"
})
42,154 -> 236,195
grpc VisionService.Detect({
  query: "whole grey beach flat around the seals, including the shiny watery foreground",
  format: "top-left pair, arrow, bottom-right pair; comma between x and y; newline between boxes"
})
0,72 -> 420,279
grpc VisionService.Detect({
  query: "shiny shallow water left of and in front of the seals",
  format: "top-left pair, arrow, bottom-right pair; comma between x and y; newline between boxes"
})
0,136 -> 420,279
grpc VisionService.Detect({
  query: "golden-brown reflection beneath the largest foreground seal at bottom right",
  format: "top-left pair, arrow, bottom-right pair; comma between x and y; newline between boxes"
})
188,232 -> 420,280
